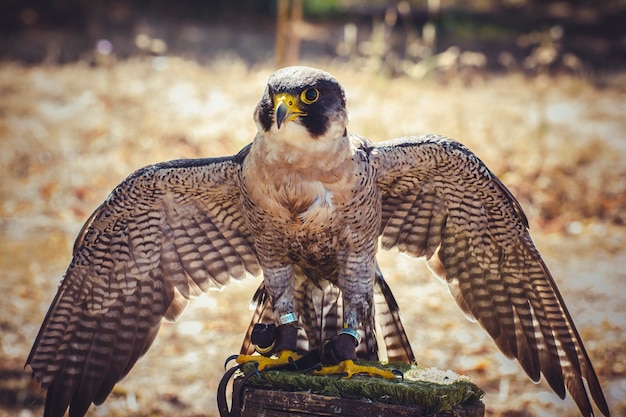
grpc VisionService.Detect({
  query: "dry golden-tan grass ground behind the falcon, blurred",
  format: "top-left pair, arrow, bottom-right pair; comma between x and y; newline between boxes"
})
0,58 -> 626,417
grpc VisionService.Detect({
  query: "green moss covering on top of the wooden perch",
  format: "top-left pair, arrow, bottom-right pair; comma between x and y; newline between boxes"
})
234,362 -> 484,416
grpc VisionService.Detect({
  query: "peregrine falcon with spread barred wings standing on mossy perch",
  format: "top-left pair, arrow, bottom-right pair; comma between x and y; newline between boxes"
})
26,67 -> 609,417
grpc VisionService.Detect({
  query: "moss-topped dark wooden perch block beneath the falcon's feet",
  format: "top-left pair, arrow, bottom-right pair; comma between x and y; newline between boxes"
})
222,364 -> 485,417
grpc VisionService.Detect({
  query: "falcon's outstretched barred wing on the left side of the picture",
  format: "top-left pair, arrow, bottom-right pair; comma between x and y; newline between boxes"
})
26,148 -> 259,417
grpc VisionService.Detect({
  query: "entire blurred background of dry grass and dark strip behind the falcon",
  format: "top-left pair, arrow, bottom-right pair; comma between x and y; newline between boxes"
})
0,0 -> 626,417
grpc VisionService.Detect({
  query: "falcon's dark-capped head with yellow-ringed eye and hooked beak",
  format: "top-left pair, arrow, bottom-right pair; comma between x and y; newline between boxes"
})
254,67 -> 348,145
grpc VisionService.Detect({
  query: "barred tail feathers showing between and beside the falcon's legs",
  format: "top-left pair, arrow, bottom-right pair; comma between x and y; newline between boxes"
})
241,265 -> 415,363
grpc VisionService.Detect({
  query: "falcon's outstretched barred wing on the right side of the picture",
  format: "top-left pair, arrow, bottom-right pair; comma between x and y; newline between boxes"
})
371,136 -> 609,416
